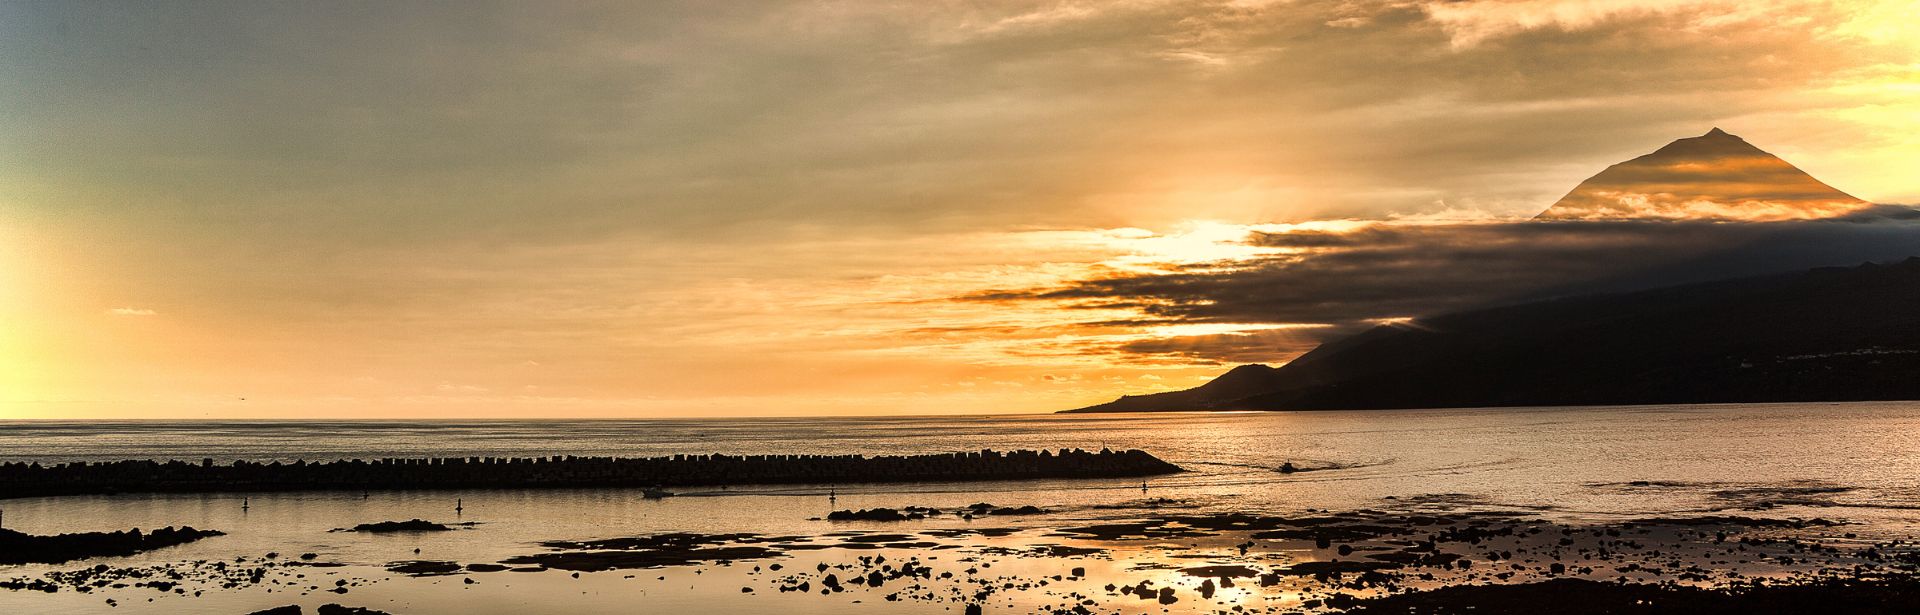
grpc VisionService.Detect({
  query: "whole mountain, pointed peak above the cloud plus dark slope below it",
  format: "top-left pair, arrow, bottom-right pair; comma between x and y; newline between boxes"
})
1071,129 -> 1920,411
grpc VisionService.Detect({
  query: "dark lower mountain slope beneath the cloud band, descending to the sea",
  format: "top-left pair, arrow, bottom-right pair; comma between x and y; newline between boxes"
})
1077,259 -> 1920,411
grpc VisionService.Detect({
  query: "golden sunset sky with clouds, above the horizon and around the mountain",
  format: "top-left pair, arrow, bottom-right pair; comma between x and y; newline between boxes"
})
0,0 -> 1920,419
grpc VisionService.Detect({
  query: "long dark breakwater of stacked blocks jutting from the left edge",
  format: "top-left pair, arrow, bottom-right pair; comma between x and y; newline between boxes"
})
0,450 -> 1181,498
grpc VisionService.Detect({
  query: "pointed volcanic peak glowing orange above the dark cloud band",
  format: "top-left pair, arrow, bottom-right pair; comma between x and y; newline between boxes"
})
1540,127 -> 1872,221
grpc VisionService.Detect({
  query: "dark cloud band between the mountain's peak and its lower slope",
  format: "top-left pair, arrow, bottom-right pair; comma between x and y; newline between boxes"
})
964,209 -> 1920,361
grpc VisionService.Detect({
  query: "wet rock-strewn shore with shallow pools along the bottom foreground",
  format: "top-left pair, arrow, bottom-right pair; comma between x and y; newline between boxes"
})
0,498 -> 1920,615
